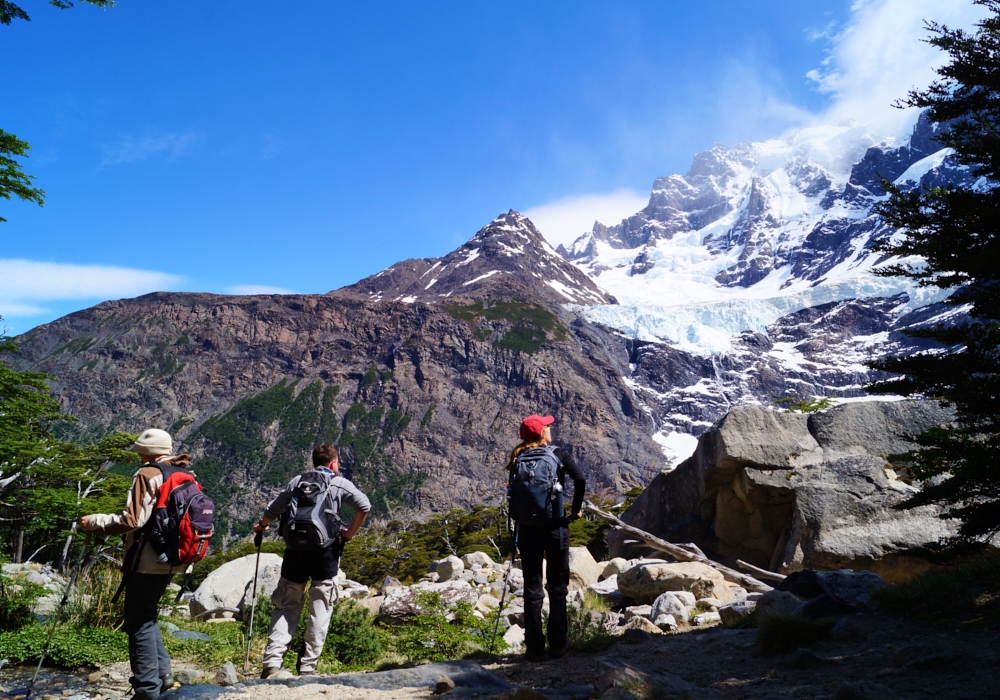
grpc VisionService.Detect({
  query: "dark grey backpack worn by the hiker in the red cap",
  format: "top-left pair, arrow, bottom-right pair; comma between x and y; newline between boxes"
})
507,446 -> 564,525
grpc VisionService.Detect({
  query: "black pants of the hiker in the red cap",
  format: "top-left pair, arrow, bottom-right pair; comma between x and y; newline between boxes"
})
517,525 -> 569,656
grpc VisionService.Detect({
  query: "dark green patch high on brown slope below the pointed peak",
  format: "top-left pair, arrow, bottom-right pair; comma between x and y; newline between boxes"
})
446,299 -> 568,355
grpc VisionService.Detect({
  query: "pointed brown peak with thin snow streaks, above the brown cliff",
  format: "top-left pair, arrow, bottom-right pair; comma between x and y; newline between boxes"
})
331,210 -> 617,306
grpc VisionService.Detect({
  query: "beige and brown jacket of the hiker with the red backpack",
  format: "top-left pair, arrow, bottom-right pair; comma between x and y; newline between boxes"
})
84,455 -> 190,574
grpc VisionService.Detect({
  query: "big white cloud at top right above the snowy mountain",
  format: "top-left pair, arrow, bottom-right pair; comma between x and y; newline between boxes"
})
808,0 -> 986,135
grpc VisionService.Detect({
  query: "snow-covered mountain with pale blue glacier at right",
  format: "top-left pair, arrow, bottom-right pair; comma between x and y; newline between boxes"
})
559,117 -> 970,464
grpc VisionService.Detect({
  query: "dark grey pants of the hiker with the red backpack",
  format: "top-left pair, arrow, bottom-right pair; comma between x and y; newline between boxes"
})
124,574 -> 172,700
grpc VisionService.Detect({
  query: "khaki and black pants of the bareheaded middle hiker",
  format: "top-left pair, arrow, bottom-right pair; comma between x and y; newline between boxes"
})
264,577 -> 338,672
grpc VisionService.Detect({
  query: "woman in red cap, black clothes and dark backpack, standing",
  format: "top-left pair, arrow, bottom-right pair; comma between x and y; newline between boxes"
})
507,415 -> 587,661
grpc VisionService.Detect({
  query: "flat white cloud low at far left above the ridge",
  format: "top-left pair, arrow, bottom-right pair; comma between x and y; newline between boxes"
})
0,259 -> 181,316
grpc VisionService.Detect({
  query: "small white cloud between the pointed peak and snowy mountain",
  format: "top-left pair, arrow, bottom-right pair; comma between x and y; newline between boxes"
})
524,189 -> 649,247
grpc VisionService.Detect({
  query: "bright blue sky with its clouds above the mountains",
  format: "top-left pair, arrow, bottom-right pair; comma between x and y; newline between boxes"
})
0,0 -> 974,333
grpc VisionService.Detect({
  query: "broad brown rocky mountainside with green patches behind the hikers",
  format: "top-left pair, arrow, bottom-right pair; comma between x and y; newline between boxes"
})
12,214 -> 664,536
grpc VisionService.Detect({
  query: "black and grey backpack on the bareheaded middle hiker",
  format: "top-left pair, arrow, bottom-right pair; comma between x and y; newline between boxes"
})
279,471 -> 343,551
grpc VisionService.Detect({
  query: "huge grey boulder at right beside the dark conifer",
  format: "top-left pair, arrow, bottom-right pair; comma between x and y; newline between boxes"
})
611,401 -> 955,584
